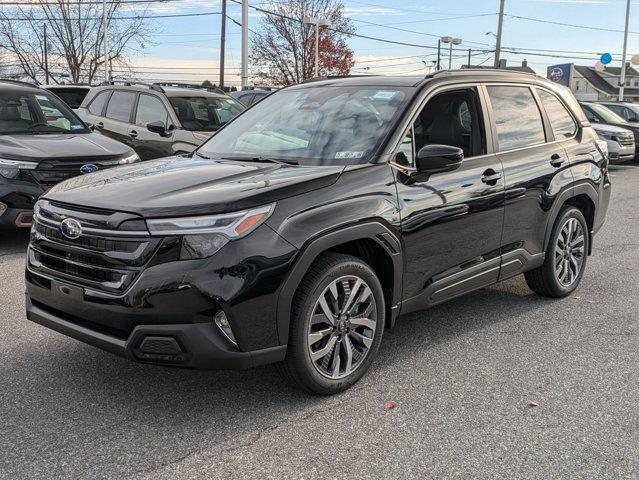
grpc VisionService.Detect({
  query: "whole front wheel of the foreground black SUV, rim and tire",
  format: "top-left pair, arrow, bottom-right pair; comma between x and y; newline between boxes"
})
282,253 -> 385,395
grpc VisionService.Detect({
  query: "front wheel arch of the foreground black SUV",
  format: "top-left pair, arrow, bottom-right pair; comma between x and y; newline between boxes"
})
277,222 -> 403,344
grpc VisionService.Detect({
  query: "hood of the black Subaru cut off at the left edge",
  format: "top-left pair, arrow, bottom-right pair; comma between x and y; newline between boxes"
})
0,132 -> 131,162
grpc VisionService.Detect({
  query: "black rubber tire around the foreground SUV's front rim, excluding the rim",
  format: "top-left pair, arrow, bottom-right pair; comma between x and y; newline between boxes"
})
280,253 -> 386,395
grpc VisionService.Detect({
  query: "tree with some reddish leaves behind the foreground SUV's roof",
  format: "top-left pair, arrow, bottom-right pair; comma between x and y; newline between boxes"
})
251,0 -> 355,85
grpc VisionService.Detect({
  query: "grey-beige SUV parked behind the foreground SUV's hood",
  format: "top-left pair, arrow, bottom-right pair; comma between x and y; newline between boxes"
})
78,83 -> 245,160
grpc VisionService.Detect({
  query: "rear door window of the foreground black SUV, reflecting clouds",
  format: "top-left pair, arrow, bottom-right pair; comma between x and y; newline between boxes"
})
488,86 -> 546,151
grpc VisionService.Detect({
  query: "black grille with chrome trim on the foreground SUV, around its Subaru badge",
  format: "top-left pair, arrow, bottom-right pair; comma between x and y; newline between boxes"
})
28,201 -> 162,293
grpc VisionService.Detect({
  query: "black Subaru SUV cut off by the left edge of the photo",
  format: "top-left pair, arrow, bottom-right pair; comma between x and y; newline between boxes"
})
0,80 -> 139,229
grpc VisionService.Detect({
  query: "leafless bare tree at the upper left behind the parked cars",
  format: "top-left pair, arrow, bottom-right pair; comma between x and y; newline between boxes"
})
0,0 -> 150,83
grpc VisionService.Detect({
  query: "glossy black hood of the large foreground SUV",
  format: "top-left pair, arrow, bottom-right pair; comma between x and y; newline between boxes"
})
45,157 -> 344,218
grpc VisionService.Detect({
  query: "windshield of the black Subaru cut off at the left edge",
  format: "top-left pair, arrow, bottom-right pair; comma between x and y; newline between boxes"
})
0,91 -> 89,135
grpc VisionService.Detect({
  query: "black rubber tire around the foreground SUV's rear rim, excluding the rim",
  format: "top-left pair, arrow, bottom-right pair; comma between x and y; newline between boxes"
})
524,205 -> 590,298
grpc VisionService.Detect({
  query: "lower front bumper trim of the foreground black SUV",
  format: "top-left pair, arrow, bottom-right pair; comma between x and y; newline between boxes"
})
26,295 -> 286,370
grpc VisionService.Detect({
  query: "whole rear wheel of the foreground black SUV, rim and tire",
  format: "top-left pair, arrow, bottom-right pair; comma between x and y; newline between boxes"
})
525,205 -> 590,298
